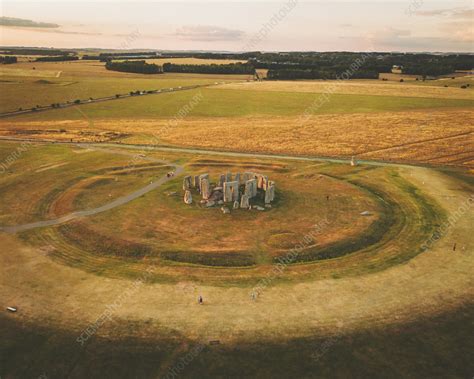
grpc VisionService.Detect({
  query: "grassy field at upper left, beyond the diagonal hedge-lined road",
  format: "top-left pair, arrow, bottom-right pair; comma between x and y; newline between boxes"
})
0,61 -> 254,112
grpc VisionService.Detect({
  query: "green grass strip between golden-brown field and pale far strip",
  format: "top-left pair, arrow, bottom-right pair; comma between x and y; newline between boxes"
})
7,88 -> 474,120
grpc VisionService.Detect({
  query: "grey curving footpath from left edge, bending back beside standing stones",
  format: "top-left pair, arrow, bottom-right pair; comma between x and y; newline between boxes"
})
0,146 -> 184,233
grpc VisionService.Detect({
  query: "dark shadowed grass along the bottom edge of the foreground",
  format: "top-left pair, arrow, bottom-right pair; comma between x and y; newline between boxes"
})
0,305 -> 474,378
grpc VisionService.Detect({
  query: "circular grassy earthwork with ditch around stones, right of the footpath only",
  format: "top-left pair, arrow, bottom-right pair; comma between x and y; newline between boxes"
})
19,162 -> 443,285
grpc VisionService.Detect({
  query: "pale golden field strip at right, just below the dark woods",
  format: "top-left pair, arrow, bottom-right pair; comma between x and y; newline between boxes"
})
221,78 -> 474,100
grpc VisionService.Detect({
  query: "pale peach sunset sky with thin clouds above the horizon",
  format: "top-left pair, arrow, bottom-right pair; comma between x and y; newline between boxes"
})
0,0 -> 474,52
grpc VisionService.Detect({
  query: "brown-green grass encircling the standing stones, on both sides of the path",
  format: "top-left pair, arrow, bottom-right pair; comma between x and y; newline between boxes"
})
0,143 -> 442,285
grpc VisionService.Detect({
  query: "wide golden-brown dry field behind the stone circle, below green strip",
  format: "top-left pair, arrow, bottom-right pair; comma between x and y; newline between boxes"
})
0,109 -> 474,168
